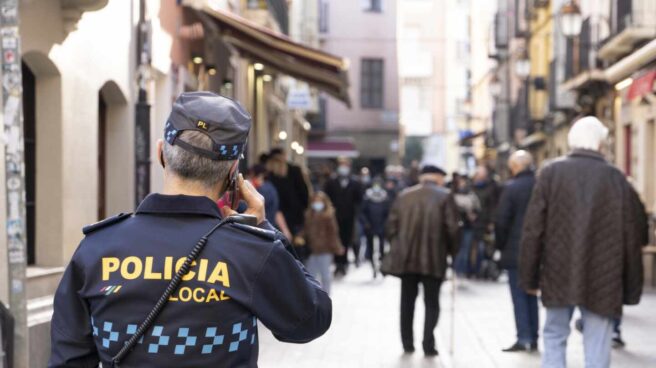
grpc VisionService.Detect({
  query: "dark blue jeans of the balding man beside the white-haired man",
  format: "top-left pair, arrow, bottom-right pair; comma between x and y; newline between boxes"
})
508,269 -> 540,344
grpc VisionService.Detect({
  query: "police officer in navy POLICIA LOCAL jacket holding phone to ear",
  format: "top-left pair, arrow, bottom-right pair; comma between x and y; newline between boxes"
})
49,92 -> 332,368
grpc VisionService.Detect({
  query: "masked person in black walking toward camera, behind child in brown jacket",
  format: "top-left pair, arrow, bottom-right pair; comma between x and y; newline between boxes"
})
324,157 -> 363,276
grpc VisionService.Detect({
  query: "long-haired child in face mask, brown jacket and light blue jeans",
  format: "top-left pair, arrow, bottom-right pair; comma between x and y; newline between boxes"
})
305,192 -> 345,294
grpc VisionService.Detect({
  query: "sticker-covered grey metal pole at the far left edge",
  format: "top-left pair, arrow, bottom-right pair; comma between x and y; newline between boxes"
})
0,0 -> 28,368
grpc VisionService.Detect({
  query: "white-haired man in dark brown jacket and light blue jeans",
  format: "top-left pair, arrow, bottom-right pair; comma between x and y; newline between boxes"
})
519,117 -> 646,368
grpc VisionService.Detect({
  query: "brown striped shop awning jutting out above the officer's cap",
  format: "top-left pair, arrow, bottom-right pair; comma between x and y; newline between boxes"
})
183,0 -> 351,107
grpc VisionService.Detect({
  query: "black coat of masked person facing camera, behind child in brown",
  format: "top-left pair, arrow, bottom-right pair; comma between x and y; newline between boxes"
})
324,177 -> 363,246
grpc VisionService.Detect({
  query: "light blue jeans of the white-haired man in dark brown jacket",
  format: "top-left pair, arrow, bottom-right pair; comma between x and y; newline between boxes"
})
542,306 -> 613,368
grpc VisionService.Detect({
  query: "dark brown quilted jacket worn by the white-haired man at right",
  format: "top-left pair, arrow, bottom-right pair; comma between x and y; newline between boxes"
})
519,150 -> 646,317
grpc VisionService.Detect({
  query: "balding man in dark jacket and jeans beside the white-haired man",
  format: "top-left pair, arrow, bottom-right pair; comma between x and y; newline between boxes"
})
494,150 -> 540,352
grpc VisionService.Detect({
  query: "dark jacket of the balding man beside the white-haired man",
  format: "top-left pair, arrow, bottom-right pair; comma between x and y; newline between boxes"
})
494,170 -> 535,269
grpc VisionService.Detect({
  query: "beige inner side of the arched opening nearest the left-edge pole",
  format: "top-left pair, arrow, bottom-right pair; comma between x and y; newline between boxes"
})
23,51 -> 64,266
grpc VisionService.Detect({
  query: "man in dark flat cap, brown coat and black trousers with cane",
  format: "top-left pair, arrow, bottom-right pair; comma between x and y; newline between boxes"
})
382,166 -> 459,356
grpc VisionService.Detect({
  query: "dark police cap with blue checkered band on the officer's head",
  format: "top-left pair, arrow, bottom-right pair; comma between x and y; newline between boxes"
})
164,92 -> 251,161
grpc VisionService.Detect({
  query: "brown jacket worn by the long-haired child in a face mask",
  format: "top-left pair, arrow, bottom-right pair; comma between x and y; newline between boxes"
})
304,210 -> 343,254
